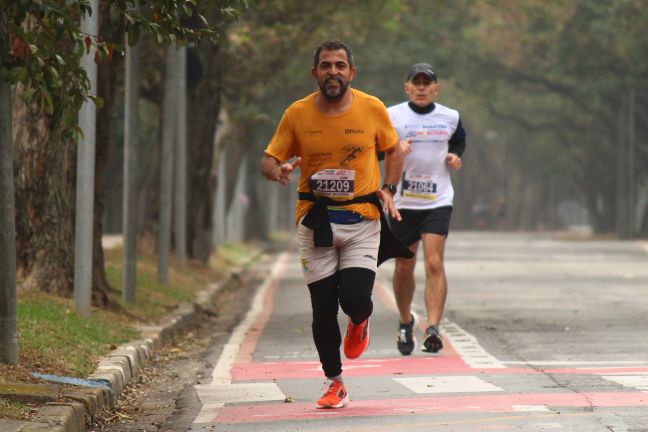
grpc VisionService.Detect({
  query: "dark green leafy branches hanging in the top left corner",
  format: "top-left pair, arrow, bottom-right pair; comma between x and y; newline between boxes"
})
0,0 -> 245,134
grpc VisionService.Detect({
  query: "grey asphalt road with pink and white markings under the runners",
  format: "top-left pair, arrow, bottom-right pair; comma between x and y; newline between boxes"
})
191,232 -> 648,432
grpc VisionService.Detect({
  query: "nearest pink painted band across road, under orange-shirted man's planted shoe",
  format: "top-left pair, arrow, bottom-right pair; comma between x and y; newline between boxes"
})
214,392 -> 648,424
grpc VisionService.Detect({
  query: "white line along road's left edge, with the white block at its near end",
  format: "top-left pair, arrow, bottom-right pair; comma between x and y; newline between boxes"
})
194,253 -> 290,424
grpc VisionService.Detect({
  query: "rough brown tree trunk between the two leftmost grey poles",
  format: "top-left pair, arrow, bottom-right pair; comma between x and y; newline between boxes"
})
13,93 -> 76,297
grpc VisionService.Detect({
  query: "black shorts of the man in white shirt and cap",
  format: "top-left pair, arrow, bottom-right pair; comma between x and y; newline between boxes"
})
389,206 -> 452,246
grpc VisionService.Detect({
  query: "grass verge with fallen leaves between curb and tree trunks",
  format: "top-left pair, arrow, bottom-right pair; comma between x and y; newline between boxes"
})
0,240 -> 259,419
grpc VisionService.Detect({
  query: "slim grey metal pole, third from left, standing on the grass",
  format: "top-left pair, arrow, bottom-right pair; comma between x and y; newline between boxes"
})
122,28 -> 139,304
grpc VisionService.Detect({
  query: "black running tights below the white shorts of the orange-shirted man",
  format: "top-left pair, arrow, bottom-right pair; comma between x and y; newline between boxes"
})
308,267 -> 376,378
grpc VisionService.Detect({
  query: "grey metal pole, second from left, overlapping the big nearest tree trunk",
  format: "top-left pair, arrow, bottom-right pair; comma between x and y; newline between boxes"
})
74,0 -> 99,317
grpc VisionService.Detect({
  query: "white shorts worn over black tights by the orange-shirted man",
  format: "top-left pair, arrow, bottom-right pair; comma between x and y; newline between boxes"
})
297,219 -> 380,285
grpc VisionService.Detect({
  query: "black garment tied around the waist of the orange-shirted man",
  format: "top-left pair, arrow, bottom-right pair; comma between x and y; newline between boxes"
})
299,192 -> 414,265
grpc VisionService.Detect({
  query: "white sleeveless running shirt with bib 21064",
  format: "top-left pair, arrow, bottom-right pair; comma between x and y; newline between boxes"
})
387,102 -> 459,210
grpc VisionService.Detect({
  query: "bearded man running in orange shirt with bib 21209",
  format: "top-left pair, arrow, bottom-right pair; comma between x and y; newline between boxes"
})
261,41 -> 408,408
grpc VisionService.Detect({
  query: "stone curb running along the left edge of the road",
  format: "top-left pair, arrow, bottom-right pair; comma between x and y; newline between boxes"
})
0,262 -> 249,432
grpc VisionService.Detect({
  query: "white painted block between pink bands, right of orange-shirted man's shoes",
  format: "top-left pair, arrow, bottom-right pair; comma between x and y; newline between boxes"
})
394,375 -> 503,394
